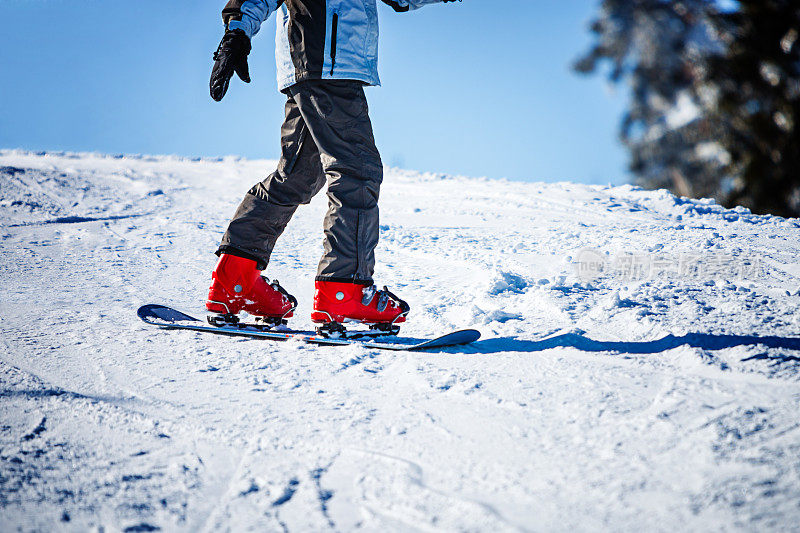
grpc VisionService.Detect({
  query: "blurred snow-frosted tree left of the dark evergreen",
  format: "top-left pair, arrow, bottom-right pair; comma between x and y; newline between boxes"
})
575,0 -> 727,200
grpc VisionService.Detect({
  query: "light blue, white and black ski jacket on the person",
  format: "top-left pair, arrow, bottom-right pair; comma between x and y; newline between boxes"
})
222,0 -> 447,90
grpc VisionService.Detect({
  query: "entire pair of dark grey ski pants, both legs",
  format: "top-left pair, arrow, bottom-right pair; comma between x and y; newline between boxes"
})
217,80 -> 383,284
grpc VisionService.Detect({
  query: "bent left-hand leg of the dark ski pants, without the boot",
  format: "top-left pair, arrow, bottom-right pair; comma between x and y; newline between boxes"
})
217,95 -> 325,270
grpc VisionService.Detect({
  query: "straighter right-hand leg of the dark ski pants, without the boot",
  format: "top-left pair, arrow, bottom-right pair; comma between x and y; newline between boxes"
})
290,80 -> 383,285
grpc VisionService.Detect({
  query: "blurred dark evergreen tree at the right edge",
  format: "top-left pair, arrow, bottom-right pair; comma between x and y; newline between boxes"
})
706,0 -> 800,216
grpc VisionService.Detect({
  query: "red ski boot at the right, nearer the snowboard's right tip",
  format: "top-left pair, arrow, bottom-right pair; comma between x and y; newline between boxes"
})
311,281 -> 410,334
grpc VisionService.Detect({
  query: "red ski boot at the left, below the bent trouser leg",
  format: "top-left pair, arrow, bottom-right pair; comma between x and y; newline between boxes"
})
206,254 -> 297,325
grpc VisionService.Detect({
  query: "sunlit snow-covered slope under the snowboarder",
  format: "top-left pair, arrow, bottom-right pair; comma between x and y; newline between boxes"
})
0,151 -> 800,531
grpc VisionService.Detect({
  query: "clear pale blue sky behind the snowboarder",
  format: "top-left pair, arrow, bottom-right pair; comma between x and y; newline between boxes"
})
0,0 -> 628,183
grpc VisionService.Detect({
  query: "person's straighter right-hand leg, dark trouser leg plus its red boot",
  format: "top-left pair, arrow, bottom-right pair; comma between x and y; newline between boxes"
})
290,80 -> 409,326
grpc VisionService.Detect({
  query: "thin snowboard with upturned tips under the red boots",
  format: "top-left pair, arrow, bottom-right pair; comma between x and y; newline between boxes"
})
136,304 -> 481,351
